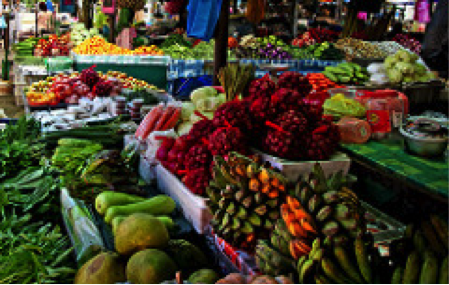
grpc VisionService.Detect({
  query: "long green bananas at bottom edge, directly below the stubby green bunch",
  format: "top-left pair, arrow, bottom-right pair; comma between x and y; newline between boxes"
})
297,235 -> 382,284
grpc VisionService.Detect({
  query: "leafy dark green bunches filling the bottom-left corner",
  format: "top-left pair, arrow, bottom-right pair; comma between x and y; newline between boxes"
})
0,167 -> 75,285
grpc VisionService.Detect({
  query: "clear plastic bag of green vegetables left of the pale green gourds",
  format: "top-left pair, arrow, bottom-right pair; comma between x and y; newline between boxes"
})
61,189 -> 105,266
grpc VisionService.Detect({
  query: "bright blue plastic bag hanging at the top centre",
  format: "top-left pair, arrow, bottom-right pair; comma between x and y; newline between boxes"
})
187,0 -> 222,41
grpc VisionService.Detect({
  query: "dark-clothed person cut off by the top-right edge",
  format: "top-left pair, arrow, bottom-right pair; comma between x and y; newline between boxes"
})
421,0 -> 449,78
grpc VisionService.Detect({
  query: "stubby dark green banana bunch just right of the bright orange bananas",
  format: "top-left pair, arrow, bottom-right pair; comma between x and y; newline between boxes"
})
292,164 -> 366,243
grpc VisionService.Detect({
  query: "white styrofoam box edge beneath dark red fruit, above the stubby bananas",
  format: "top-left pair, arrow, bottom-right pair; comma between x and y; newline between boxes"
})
255,150 -> 351,182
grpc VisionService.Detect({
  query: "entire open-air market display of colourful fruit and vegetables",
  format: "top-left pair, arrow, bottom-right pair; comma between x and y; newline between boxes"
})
0,0 -> 449,285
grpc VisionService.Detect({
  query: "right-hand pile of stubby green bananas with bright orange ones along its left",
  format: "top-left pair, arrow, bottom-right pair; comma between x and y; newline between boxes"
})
256,164 -> 366,280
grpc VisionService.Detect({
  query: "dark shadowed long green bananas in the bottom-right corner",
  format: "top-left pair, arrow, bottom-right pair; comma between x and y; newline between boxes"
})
390,215 -> 449,284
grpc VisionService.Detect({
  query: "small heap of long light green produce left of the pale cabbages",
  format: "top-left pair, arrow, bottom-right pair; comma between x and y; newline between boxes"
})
322,62 -> 370,84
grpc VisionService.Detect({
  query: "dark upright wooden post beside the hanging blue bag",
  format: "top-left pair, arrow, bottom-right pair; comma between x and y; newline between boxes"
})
214,0 -> 231,85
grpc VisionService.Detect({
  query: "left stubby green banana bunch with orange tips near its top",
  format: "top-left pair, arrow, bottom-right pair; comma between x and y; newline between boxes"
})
206,153 -> 287,251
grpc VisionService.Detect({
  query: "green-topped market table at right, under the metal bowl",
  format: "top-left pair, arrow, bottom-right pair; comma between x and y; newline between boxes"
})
342,140 -> 449,221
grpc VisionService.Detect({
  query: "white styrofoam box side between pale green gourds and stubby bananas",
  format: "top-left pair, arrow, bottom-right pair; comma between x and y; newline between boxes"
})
156,164 -> 212,234
